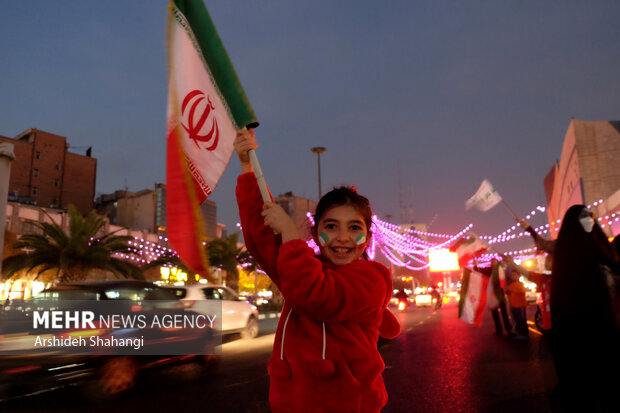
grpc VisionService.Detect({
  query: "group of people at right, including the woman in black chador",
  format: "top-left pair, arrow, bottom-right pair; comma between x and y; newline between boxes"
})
480,205 -> 620,411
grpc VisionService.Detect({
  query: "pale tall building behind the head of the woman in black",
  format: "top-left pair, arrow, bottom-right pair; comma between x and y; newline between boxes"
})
544,119 -> 620,238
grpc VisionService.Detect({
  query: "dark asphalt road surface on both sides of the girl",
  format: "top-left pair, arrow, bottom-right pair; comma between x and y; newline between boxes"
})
0,305 -> 561,413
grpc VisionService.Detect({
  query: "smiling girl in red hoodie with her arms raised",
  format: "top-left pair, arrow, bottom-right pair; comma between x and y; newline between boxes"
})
235,131 -> 400,413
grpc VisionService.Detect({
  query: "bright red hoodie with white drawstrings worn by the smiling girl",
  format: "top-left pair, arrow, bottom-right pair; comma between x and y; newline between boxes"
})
237,173 -> 400,413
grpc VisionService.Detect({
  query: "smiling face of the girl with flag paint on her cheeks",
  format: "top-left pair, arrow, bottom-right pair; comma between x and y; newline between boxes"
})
314,205 -> 368,266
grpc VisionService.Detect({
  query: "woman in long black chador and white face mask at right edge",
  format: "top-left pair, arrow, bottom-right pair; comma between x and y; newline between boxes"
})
551,205 -> 620,403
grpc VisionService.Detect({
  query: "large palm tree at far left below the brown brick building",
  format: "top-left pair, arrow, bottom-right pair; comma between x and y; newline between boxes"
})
2,205 -> 143,283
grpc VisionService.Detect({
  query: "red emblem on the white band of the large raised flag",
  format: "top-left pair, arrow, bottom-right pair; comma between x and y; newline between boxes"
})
181,90 -> 220,151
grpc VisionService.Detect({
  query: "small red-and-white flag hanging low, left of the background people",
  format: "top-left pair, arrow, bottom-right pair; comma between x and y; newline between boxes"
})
459,268 -> 489,327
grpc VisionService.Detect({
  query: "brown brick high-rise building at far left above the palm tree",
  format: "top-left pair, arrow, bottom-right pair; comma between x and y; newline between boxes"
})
0,128 -> 97,214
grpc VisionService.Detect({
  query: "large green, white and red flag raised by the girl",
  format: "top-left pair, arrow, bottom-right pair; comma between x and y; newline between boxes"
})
166,0 -> 258,277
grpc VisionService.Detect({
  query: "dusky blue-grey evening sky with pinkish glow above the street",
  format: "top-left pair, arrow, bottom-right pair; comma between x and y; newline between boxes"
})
0,0 -> 620,248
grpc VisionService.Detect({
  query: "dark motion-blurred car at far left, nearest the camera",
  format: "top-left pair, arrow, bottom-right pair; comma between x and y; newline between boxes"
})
0,280 -> 216,400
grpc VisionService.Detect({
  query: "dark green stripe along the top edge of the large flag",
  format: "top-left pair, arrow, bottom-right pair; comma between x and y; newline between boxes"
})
174,0 -> 258,128
